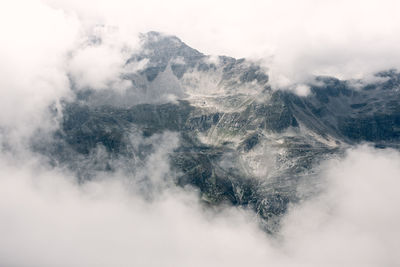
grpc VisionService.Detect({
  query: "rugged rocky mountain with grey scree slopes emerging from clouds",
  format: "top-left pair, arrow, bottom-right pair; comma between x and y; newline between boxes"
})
32,32 -> 400,232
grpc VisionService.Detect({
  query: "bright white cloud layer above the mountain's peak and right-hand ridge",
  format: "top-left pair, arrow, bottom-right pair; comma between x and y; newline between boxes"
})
47,0 -> 400,86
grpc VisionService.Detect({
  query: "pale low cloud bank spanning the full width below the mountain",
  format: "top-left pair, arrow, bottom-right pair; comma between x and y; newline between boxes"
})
0,143 -> 400,266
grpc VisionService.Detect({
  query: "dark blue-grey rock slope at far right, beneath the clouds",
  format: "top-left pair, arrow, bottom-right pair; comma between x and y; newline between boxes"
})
288,72 -> 400,147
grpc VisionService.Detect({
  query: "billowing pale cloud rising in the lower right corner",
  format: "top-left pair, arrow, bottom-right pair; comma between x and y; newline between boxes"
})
281,146 -> 400,266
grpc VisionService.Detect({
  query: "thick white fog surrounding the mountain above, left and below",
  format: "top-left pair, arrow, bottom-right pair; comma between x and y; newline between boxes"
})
0,0 -> 400,266
